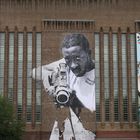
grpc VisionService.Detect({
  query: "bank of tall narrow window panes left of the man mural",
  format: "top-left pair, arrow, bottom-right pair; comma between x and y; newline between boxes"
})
0,32 -> 41,122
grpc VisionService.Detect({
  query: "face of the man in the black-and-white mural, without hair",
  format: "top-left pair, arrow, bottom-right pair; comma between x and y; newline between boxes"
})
62,46 -> 89,77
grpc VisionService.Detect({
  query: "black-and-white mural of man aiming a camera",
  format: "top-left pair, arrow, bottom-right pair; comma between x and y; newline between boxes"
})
32,33 -> 96,140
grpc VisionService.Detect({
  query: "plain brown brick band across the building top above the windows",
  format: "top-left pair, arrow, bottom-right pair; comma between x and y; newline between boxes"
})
0,0 -> 140,31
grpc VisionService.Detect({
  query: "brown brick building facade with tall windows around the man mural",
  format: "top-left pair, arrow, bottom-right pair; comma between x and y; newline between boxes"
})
0,0 -> 140,140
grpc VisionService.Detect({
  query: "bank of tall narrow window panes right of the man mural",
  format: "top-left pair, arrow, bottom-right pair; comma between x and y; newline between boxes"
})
95,33 -> 137,122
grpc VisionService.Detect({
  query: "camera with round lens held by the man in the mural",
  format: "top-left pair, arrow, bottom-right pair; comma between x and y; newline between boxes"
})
53,63 -> 72,105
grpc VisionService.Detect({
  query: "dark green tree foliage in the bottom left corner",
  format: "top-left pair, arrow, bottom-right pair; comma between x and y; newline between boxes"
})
0,96 -> 25,140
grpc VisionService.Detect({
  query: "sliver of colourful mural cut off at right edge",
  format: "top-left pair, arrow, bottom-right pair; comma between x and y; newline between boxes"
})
136,33 -> 140,125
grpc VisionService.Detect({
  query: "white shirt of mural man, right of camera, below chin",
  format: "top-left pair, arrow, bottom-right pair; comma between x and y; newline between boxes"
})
68,69 -> 95,111
